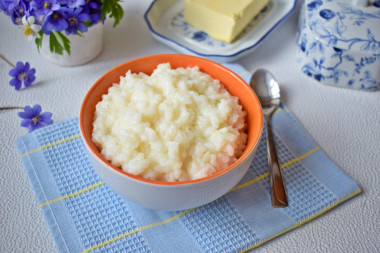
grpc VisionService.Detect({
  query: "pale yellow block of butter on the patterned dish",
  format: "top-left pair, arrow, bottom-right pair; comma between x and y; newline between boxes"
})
184,0 -> 269,43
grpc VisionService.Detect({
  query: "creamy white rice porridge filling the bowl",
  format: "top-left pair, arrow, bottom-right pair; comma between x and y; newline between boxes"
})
92,63 -> 247,182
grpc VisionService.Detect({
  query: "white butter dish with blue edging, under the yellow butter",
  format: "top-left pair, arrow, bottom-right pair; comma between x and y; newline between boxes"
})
145,0 -> 297,62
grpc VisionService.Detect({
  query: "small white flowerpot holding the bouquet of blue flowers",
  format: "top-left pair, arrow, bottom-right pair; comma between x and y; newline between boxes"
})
40,24 -> 104,67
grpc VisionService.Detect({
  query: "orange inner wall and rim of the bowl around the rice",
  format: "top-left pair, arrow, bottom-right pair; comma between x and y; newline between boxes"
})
79,54 -> 263,185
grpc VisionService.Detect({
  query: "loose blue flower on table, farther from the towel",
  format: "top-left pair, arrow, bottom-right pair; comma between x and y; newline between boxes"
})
9,61 -> 36,90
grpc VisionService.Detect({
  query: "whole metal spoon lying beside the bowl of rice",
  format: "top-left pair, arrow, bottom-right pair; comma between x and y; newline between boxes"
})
250,69 -> 288,207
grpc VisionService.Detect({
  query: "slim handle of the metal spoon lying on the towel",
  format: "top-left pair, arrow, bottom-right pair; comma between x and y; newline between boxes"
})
266,115 -> 288,207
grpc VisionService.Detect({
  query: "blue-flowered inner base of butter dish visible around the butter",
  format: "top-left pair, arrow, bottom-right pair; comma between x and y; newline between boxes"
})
171,1 -> 273,49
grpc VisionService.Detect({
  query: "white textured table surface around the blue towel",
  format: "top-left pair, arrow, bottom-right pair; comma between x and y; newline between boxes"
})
0,0 -> 380,252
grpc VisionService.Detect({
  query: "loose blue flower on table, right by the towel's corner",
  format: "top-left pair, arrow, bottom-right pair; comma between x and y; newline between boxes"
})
18,104 -> 53,133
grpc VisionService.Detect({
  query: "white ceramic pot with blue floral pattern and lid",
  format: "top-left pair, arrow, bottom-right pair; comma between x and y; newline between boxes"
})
297,0 -> 380,90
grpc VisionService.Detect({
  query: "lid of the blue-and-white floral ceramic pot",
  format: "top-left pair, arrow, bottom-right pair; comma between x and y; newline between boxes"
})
305,0 -> 380,53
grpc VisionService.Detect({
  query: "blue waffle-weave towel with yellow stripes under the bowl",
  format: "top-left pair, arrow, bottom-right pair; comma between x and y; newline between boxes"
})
17,64 -> 360,253
